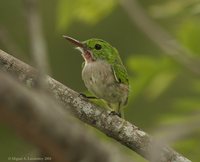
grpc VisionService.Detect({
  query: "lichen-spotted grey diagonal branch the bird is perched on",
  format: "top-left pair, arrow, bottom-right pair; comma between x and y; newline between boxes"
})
0,50 -> 190,162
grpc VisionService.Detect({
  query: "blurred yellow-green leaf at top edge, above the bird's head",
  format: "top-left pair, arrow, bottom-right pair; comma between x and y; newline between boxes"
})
57,0 -> 116,30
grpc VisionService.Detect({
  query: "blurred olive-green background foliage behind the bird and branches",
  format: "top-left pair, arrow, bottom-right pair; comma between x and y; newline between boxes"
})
0,0 -> 200,162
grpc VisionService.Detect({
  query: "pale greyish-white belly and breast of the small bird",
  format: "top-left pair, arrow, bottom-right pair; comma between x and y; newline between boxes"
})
82,61 -> 128,105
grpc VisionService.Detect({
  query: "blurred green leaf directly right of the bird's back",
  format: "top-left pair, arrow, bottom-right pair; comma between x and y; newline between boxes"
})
128,56 -> 178,100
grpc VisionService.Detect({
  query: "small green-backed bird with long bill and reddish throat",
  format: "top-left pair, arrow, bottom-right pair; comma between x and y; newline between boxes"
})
63,36 -> 129,117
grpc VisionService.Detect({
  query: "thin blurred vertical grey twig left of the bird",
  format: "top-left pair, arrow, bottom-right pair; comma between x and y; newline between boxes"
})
24,0 -> 49,88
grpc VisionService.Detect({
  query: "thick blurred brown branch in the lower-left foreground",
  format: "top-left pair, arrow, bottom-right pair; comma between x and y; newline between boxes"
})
0,72 -> 133,162
